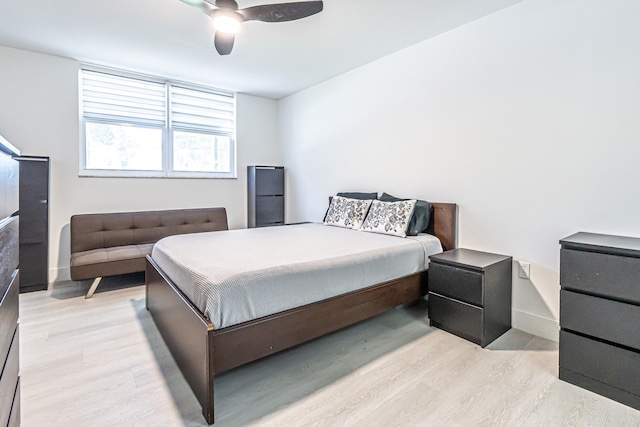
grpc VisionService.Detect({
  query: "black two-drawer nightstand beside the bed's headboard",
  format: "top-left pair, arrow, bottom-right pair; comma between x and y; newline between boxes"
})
428,249 -> 512,347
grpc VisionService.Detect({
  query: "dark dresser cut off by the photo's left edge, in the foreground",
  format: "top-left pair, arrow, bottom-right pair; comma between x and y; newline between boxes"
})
0,137 -> 20,427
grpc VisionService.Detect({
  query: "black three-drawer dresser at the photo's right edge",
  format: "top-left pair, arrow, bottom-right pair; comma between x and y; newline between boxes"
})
559,233 -> 640,409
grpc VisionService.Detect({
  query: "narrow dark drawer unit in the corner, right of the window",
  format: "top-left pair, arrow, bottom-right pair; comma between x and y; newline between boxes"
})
247,166 -> 284,228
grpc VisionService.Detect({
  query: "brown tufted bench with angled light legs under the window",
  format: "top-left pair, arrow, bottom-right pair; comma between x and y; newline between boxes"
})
71,208 -> 228,298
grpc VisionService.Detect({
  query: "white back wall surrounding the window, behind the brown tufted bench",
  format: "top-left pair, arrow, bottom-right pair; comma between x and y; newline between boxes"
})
0,46 -> 282,281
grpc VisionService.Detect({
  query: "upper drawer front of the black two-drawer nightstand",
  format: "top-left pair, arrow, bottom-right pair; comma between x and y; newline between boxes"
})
428,261 -> 483,306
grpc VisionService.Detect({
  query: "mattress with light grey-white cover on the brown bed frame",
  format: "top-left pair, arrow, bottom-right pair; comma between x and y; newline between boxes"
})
151,224 -> 442,329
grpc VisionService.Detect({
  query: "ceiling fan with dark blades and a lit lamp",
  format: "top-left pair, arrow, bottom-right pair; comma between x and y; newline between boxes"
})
181,0 -> 322,55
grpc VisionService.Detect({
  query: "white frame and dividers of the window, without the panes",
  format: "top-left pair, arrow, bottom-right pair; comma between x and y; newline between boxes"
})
78,64 -> 238,179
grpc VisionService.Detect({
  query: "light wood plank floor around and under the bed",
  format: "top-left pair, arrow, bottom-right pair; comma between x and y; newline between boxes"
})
20,276 -> 640,427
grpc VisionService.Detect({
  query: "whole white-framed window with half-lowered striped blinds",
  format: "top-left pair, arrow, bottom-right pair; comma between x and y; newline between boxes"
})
80,68 -> 236,178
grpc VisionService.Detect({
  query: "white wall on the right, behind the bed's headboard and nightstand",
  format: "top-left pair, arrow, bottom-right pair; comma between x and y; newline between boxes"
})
278,0 -> 640,339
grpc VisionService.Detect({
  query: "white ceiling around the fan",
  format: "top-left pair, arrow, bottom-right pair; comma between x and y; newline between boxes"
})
0,0 -> 521,99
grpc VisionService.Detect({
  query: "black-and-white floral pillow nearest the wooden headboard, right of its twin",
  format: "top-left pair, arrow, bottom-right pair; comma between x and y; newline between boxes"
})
362,200 -> 416,237
